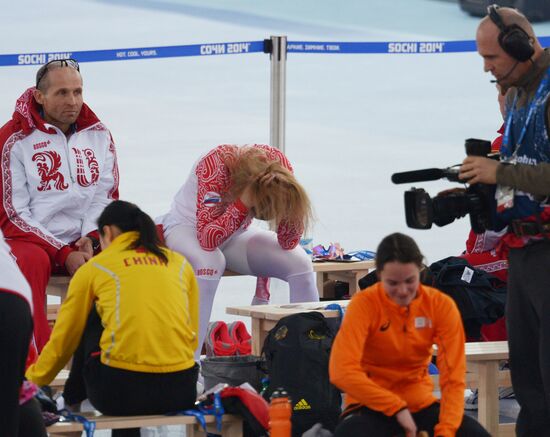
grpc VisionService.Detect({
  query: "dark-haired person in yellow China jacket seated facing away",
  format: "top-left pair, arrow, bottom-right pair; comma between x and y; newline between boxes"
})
26,201 -> 198,436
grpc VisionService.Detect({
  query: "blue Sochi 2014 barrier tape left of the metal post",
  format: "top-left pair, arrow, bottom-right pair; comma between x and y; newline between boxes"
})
0,41 -> 264,66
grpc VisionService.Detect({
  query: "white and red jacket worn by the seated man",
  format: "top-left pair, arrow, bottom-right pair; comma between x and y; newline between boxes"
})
0,88 -> 118,266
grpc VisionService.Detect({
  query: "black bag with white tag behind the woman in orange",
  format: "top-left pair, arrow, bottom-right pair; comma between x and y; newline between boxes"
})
430,256 -> 506,339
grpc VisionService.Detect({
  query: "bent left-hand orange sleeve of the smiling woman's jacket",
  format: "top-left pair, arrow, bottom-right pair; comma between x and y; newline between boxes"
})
329,293 -> 407,416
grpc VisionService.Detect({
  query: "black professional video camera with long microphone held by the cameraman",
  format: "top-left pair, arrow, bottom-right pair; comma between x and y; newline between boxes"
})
391,138 -> 498,234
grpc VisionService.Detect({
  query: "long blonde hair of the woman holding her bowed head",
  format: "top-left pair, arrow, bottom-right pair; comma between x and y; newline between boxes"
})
226,146 -> 313,230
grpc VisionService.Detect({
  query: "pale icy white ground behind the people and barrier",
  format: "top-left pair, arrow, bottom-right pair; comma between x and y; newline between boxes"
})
0,0 -> 550,430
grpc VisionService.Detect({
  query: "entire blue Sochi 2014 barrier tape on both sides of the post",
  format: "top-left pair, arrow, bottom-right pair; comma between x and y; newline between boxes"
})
0,36 -> 550,67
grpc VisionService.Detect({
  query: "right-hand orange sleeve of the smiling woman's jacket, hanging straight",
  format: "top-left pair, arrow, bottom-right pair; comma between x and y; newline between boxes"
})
434,293 -> 466,437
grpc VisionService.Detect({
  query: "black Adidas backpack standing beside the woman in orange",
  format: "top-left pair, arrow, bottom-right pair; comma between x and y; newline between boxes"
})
262,312 -> 341,437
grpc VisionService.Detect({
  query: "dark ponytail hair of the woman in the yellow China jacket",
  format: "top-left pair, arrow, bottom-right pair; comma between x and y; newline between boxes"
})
97,200 -> 168,263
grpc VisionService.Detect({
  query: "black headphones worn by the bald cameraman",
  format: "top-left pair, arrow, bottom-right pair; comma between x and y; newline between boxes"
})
487,5 -> 535,62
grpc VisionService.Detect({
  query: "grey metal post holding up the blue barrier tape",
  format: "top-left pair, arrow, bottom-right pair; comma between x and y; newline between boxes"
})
266,36 -> 286,153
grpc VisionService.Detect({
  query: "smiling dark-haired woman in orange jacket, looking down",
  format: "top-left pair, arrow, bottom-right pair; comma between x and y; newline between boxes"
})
329,233 -> 489,437
